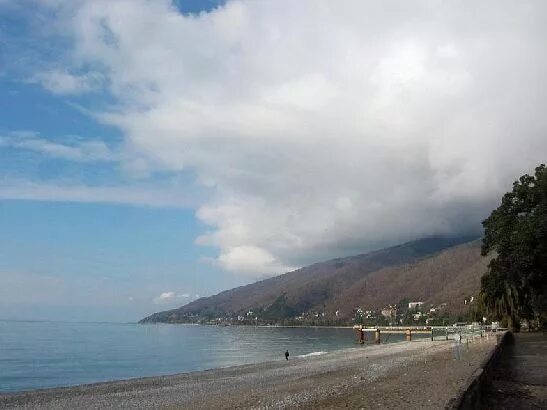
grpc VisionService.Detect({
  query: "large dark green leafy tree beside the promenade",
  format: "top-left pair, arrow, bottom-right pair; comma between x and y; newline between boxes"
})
480,164 -> 547,328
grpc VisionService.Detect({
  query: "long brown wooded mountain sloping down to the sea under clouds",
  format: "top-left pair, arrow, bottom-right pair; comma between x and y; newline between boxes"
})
140,237 -> 488,323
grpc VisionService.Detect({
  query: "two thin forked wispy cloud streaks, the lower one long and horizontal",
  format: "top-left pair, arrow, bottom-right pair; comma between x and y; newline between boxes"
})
0,131 -> 203,208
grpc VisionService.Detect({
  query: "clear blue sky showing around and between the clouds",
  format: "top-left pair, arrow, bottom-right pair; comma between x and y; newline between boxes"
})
0,1 -> 235,321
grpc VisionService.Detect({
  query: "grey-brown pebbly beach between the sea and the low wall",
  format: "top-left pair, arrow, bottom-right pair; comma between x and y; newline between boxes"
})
0,338 -> 495,409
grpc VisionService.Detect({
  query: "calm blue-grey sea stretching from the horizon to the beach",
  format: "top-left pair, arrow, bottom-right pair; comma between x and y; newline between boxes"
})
0,321 -> 416,393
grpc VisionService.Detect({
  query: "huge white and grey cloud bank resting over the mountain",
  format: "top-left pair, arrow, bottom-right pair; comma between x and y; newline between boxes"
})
36,0 -> 547,276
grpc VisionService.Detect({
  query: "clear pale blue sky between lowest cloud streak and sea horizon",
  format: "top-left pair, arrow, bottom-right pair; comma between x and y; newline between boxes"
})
0,201 -> 242,320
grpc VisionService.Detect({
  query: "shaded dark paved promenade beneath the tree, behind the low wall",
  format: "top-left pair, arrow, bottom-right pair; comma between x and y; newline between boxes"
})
485,333 -> 547,409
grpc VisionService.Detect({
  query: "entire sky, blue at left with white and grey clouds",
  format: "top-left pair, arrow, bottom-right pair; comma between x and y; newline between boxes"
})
0,0 -> 547,321
